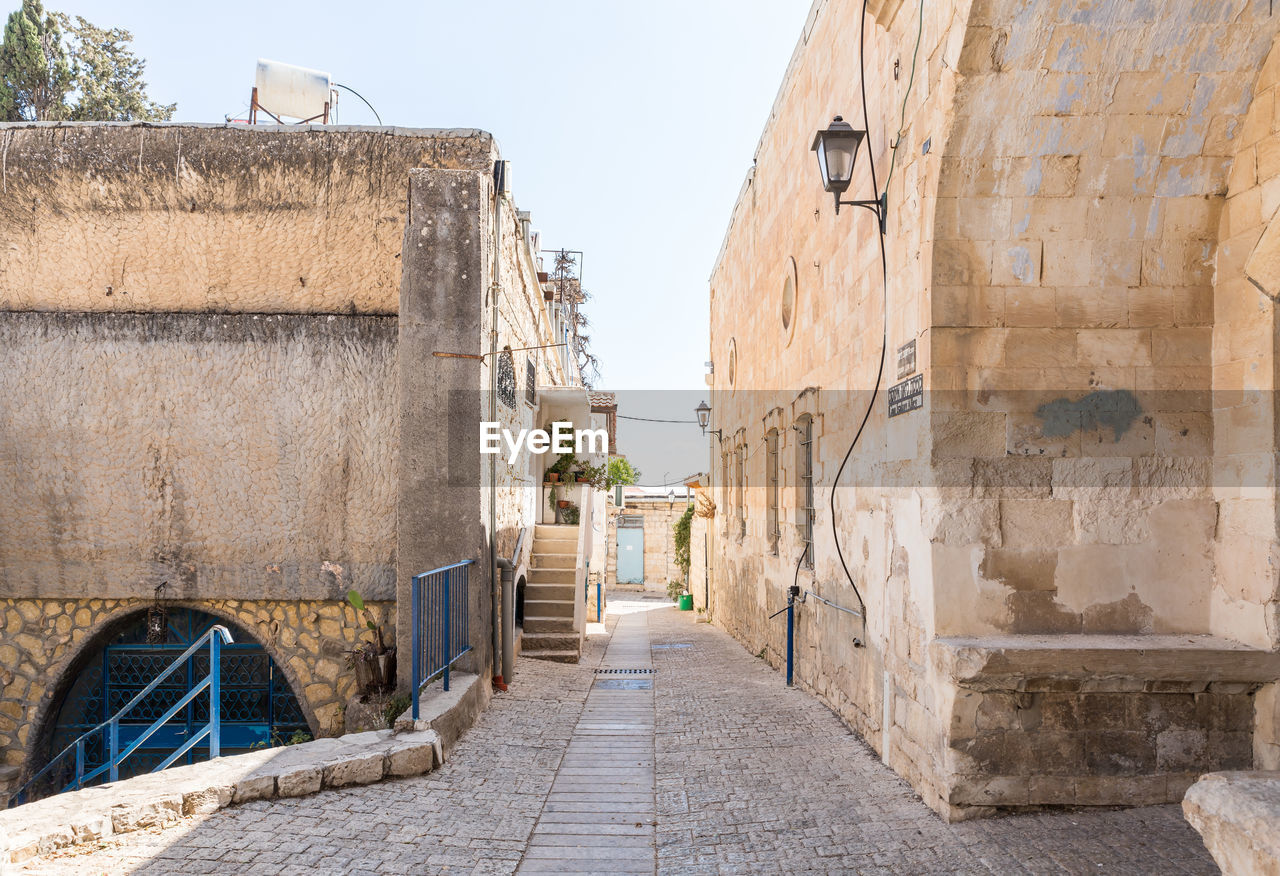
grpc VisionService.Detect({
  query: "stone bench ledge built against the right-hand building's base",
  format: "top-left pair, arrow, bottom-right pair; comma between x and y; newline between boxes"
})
926,635 -> 1280,818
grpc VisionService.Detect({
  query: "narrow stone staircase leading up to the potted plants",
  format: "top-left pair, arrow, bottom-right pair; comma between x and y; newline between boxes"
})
520,524 -> 582,663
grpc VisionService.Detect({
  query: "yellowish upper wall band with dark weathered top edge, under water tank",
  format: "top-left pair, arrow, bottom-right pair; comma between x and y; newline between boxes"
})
0,123 -> 494,314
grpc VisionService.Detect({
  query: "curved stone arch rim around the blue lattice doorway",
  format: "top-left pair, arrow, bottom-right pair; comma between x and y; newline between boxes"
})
22,599 -> 319,775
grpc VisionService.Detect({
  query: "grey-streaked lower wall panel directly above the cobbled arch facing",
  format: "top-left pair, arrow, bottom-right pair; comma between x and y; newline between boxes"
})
0,312 -> 398,601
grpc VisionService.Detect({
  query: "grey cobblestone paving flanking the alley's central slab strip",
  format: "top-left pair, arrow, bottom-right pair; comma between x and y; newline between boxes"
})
28,601 -> 1216,875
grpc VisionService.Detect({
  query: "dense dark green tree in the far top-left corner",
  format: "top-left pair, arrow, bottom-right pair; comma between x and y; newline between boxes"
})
0,0 -> 72,122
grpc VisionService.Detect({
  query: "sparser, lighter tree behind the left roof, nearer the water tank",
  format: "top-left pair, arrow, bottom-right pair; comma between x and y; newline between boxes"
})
58,13 -> 178,122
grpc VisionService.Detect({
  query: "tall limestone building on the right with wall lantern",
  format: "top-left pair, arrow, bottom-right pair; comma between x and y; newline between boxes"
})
710,0 -> 1280,818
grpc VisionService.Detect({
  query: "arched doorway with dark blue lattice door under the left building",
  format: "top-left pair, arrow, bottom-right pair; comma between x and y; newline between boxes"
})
31,608 -> 308,798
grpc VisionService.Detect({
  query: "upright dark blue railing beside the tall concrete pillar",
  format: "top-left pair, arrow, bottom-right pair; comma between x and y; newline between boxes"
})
410,560 -> 475,721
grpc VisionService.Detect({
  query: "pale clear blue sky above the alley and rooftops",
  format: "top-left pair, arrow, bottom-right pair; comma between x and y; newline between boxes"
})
57,0 -> 812,482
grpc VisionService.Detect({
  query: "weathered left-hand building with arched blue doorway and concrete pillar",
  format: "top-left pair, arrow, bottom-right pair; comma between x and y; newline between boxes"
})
0,124 -> 586,794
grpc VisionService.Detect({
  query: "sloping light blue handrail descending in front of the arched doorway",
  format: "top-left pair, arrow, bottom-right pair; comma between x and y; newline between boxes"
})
9,626 -> 232,807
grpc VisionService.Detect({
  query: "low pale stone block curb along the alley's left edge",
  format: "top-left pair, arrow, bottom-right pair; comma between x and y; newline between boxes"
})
0,730 -> 444,870
